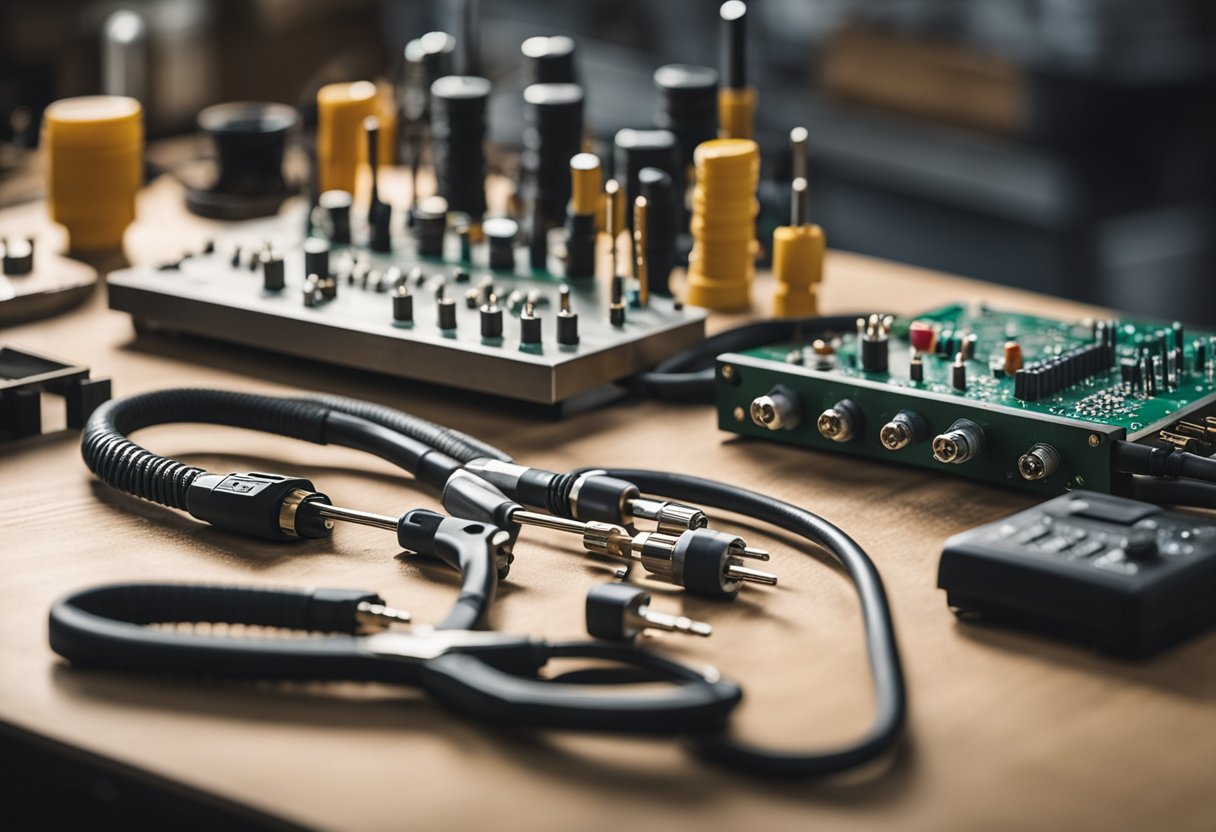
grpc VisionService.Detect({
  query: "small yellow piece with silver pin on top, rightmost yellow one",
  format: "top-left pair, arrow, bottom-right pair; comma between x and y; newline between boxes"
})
772,178 -> 827,317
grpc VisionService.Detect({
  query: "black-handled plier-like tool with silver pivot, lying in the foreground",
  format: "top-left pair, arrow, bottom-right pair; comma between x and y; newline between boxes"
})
50,584 -> 742,733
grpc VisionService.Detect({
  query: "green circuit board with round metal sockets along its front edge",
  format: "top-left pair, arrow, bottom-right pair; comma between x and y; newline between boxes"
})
716,304 -> 1216,494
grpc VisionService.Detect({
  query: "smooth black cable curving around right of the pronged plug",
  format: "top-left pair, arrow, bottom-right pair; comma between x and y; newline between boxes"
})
588,468 -> 907,776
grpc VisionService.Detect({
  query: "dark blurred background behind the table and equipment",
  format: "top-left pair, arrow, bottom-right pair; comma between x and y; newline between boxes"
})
0,0 -> 1216,324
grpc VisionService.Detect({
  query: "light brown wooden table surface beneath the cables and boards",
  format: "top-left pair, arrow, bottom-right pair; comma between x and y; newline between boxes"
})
0,184 -> 1216,832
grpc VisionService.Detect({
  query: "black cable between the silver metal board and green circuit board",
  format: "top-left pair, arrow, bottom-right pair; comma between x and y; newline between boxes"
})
629,313 -> 869,403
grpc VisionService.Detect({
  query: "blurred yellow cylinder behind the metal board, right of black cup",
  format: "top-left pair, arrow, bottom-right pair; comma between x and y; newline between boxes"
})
316,81 -> 396,193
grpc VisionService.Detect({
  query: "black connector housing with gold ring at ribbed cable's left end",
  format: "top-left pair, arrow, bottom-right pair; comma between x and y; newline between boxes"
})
186,473 -> 332,541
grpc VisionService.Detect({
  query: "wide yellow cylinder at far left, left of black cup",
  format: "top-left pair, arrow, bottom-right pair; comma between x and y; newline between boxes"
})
43,95 -> 143,252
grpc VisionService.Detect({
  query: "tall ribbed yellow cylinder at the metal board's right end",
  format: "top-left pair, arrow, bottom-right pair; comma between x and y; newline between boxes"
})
687,139 -> 760,311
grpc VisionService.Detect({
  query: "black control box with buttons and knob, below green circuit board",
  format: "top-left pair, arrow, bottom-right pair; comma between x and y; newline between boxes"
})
938,491 -> 1216,657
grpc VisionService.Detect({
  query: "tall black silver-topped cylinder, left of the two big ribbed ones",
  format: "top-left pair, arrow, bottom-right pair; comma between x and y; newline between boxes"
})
430,75 -> 491,223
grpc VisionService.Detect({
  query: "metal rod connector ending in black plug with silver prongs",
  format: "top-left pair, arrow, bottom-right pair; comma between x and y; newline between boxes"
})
511,511 -> 777,598
